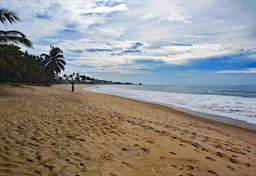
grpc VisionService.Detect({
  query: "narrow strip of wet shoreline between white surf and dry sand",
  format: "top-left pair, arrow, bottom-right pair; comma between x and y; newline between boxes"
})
81,85 -> 256,131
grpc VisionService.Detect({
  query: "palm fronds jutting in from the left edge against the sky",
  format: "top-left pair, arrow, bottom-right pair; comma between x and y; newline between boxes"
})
0,8 -> 33,48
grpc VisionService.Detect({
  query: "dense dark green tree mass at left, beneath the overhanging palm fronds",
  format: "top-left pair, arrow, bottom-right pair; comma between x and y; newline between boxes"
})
0,44 -> 46,83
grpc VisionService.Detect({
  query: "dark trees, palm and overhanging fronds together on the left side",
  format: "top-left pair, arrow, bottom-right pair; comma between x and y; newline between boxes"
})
0,8 -> 63,85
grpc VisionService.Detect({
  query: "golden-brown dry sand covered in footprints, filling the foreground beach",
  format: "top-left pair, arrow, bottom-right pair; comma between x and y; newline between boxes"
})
0,86 -> 256,176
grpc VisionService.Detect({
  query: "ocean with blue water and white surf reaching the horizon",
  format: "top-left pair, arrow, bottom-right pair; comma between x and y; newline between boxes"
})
86,85 -> 256,125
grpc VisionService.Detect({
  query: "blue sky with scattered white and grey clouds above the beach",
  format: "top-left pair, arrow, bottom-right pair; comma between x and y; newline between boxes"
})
0,0 -> 256,84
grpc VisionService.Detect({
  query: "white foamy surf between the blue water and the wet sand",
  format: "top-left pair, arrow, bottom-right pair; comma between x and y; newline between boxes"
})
86,85 -> 256,125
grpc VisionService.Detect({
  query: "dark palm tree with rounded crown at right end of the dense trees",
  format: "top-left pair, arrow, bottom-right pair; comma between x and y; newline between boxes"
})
40,45 -> 66,79
